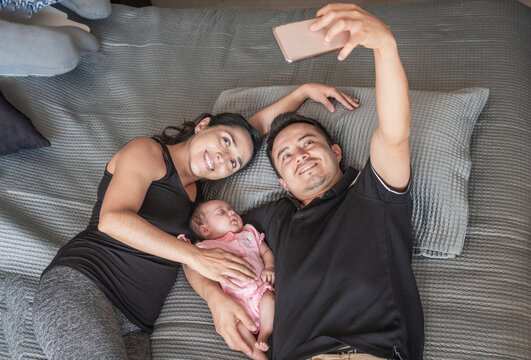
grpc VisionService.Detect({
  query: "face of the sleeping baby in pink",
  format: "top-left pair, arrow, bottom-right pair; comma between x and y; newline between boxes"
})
201,200 -> 243,239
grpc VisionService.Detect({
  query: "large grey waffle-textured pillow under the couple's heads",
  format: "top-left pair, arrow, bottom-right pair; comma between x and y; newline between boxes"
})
203,86 -> 489,258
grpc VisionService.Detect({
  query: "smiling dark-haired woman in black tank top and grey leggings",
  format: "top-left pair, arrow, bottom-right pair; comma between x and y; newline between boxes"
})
33,84 -> 357,359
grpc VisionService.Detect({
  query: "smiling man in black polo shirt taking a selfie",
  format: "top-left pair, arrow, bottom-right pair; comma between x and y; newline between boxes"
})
187,4 -> 424,360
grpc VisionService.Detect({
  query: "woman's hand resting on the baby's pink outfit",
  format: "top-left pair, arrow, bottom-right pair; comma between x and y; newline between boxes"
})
188,248 -> 257,290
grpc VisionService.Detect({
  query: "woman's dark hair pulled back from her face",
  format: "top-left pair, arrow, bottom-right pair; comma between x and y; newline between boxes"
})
155,113 -> 260,163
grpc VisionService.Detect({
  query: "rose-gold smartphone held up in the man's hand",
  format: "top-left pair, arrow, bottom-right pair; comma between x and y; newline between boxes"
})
273,19 -> 350,63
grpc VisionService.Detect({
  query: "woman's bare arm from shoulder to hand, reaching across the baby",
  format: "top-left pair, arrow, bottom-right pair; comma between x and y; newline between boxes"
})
98,138 -> 255,286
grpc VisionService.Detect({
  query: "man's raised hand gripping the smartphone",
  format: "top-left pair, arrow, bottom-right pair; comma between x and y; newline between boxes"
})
310,4 -> 396,60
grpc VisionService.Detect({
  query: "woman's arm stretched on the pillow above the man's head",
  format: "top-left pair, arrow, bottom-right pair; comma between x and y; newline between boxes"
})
249,83 -> 360,136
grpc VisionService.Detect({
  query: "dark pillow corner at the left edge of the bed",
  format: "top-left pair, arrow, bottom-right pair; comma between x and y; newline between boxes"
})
0,93 -> 50,155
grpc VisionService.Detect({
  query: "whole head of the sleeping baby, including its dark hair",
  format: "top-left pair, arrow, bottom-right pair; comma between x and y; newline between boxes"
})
190,200 -> 243,239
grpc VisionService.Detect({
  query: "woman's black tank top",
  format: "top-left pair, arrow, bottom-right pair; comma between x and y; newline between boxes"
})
43,139 -> 199,333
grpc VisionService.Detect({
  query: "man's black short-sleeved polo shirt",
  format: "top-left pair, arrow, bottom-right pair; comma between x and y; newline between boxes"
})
244,160 -> 424,360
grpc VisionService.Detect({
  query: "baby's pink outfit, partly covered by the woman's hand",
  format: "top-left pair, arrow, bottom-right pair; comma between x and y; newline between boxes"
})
196,224 -> 273,332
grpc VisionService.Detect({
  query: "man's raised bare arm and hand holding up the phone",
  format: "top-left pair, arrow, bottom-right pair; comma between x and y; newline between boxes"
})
312,4 -> 411,191
